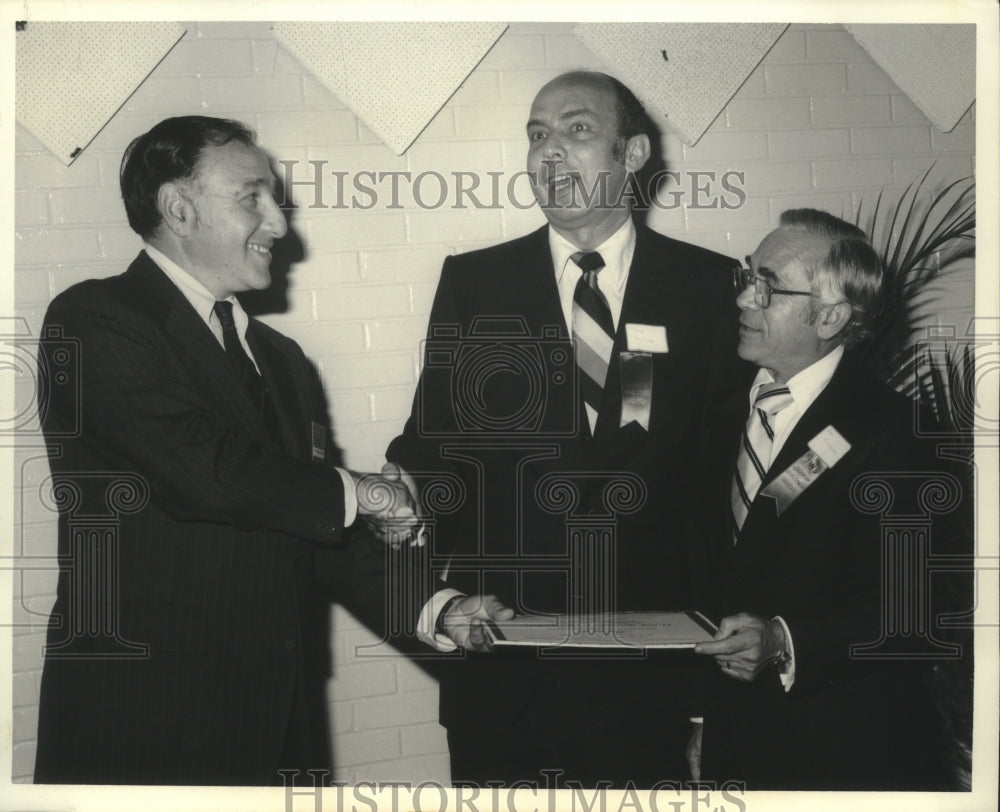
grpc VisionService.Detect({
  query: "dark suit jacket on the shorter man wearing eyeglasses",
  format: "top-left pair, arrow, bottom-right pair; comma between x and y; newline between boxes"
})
703,356 -> 961,790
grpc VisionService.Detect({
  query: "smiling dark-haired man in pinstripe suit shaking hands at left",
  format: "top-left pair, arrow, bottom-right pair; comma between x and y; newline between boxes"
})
35,116 -> 428,785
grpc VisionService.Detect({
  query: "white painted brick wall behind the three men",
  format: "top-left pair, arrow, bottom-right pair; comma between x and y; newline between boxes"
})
13,22 -> 975,782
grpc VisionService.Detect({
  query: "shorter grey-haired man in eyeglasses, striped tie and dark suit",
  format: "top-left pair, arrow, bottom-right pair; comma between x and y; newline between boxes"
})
695,209 -> 964,790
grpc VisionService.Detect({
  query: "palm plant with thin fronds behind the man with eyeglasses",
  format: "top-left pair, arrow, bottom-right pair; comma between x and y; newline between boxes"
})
855,166 -> 976,789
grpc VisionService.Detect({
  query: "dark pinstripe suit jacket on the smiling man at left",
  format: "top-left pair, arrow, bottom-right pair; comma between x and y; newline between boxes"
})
35,253 -> 394,784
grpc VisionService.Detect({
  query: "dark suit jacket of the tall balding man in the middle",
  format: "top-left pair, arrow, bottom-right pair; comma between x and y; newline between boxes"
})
387,225 -> 742,778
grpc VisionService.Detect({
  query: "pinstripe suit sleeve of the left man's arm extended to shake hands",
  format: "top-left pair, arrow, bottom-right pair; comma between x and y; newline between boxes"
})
41,289 -> 354,542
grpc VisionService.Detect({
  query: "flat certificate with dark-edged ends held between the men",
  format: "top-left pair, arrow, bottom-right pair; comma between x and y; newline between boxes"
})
486,612 -> 717,649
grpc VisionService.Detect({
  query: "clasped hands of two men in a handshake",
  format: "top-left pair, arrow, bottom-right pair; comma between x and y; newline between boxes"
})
351,462 -> 425,548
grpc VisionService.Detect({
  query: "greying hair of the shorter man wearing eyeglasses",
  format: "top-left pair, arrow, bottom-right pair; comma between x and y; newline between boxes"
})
778,209 -> 885,347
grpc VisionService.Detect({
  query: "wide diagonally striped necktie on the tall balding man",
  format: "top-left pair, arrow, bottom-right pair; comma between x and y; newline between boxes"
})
571,251 -> 615,412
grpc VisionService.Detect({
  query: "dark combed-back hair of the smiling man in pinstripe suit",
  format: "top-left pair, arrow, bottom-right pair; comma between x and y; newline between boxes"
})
119,116 -> 256,238
